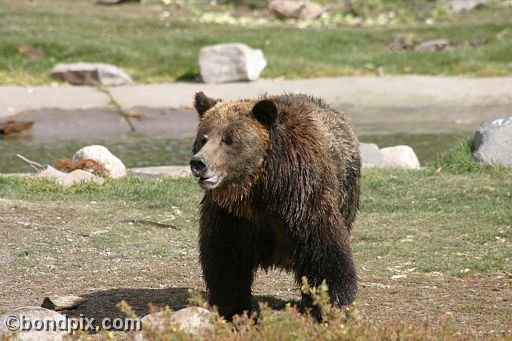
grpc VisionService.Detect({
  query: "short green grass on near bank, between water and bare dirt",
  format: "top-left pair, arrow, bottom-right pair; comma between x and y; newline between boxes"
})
0,165 -> 512,275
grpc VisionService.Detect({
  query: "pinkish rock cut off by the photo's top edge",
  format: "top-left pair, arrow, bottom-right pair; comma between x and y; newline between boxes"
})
268,0 -> 326,19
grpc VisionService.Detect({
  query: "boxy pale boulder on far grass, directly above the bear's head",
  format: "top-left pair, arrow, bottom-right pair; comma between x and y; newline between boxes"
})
199,43 -> 267,83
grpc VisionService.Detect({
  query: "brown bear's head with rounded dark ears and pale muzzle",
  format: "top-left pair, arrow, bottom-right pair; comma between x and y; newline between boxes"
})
190,92 -> 277,195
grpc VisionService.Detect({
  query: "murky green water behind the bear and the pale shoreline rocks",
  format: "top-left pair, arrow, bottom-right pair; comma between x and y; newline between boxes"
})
0,133 -> 469,173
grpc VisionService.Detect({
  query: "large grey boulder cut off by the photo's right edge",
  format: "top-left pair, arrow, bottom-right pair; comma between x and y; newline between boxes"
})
473,116 -> 512,167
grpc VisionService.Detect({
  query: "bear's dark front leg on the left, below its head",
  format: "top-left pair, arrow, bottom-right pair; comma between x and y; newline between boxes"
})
199,201 -> 255,320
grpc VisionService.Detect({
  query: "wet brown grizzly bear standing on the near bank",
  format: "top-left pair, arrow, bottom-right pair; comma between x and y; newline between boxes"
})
190,92 -> 361,319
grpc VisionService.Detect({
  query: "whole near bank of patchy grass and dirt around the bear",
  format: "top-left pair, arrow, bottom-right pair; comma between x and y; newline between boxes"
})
0,143 -> 512,340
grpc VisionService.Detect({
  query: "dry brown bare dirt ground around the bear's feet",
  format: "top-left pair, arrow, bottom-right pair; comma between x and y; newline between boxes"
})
0,199 -> 512,336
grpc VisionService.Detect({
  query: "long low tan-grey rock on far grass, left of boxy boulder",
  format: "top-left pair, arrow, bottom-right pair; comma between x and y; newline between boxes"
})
50,62 -> 133,86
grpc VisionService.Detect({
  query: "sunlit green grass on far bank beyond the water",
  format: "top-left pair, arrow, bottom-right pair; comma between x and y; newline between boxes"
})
0,0 -> 512,84
